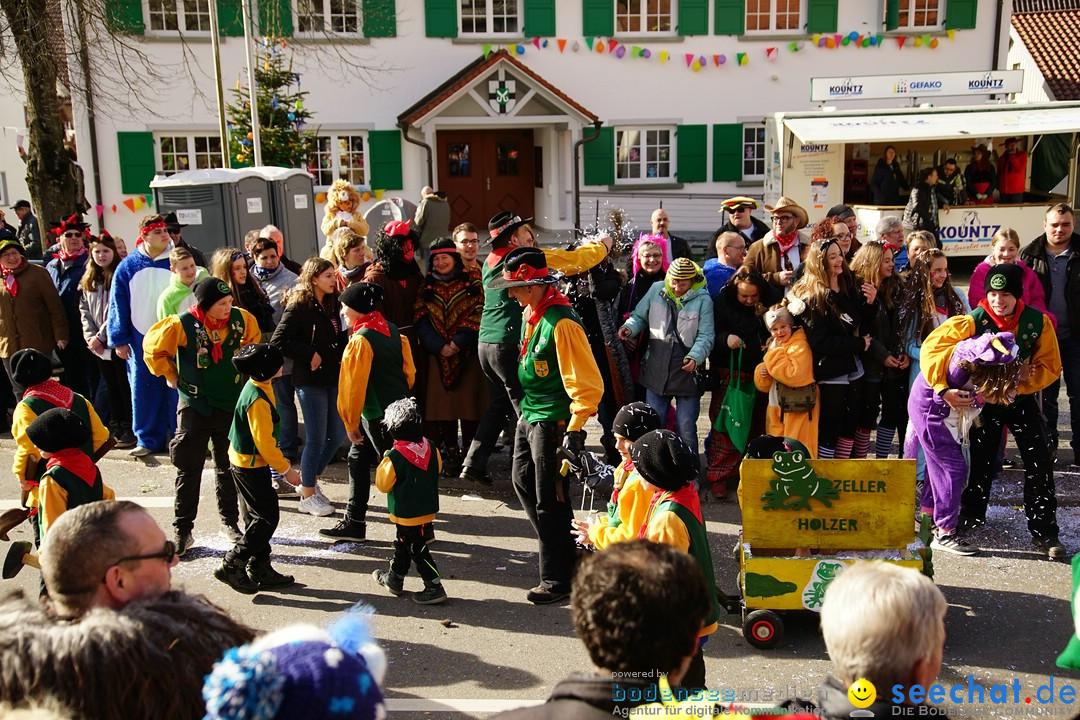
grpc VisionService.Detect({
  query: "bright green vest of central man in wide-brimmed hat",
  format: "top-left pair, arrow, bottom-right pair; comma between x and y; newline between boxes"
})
517,305 -> 581,422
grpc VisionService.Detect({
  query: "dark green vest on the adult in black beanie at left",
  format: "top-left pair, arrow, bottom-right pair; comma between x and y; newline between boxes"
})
176,308 -> 245,417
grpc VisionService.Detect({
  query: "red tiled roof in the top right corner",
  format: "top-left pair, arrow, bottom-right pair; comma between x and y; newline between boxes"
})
1012,3 -> 1080,100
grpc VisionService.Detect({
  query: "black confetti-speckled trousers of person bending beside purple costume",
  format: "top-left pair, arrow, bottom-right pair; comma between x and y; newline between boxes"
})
960,395 -> 1058,540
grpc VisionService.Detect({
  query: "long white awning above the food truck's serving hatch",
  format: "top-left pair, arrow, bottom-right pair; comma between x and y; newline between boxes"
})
784,106 -> 1080,142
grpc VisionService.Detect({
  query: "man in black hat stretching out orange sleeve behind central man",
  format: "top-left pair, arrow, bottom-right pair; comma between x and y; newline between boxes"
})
461,210 -> 611,485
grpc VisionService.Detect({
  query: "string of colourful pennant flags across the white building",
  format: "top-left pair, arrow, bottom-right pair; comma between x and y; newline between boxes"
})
483,29 -> 956,72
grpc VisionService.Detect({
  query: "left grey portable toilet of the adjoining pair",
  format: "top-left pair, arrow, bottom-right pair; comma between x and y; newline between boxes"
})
150,167 -> 273,255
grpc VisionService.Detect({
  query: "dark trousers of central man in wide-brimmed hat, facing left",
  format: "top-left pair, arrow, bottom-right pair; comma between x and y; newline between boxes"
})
511,418 -> 577,592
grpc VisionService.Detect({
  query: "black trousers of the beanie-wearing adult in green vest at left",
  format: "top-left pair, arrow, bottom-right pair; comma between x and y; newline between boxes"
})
168,405 -> 240,532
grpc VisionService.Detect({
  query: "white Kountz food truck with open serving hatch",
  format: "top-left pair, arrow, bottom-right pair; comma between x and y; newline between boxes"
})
765,103 -> 1080,257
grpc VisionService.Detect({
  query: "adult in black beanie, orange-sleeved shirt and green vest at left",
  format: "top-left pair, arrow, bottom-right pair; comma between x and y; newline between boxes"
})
143,277 -> 261,557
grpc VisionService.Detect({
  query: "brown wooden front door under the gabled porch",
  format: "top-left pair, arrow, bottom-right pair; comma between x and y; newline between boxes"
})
436,130 -> 534,235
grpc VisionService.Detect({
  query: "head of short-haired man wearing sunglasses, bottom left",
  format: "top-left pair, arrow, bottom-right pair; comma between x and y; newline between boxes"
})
39,501 -> 179,617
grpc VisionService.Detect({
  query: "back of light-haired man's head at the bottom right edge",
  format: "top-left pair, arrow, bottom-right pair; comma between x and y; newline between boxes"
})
799,561 -> 947,719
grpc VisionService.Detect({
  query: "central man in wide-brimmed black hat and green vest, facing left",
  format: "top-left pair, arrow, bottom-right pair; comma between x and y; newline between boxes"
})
487,247 -> 604,604
